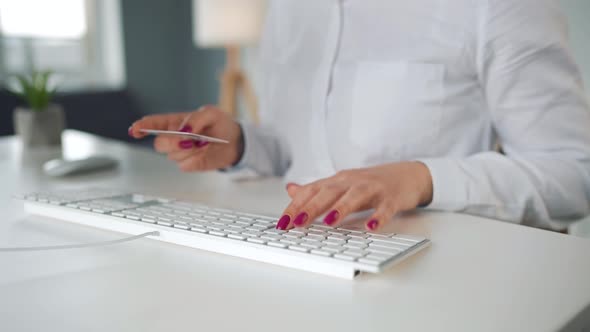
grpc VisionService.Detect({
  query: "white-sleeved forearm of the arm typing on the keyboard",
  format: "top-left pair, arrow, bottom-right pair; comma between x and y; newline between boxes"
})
421,152 -> 590,229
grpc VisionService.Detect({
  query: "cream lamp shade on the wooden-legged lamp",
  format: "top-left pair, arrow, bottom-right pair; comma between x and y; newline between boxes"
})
193,0 -> 266,47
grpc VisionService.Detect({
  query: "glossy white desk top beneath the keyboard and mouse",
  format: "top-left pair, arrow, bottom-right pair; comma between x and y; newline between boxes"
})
0,131 -> 590,332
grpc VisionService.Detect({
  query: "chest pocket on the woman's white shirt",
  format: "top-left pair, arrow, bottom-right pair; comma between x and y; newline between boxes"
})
349,62 -> 444,161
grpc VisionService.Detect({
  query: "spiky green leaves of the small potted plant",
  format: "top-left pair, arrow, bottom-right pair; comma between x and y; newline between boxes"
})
12,71 -> 56,112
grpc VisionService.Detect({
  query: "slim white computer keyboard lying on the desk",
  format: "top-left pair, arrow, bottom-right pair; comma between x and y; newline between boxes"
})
20,189 -> 430,279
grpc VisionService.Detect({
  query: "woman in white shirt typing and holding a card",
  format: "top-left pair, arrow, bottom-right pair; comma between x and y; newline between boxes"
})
130,0 -> 590,230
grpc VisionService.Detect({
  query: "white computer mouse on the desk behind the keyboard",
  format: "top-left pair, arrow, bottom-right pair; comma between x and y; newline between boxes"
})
43,156 -> 118,176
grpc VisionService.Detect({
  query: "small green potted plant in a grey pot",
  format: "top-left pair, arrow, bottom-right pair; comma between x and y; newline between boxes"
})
12,71 -> 65,147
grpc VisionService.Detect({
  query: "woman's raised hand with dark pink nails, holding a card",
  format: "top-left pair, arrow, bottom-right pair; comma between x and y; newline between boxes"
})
129,106 -> 244,172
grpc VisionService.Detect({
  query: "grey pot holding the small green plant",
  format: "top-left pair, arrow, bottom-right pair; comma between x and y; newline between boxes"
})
14,104 -> 66,147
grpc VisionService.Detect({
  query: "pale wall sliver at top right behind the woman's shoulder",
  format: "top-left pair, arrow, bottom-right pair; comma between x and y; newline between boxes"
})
561,0 -> 590,94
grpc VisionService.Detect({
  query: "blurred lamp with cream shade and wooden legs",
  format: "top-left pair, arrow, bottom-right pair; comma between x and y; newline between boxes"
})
193,0 -> 266,123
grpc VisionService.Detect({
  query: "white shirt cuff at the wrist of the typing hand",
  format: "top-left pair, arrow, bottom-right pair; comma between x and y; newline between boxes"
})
416,158 -> 469,211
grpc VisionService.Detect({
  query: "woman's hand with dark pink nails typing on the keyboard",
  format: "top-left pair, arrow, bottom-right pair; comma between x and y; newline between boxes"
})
277,162 -> 432,231
